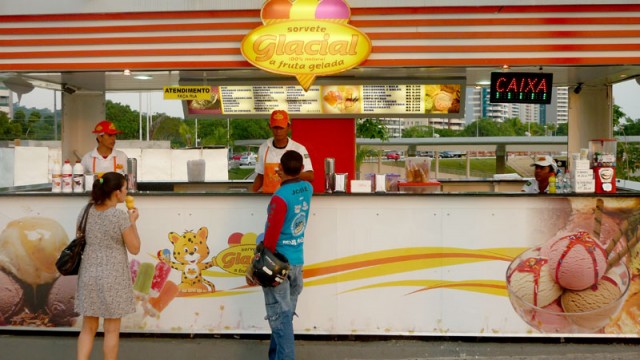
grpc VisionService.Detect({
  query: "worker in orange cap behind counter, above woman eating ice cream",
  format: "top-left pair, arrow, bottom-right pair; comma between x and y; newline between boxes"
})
81,120 -> 127,176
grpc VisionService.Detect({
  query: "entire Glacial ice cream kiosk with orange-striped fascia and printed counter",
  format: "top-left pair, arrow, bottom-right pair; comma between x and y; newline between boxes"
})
0,0 -> 640,340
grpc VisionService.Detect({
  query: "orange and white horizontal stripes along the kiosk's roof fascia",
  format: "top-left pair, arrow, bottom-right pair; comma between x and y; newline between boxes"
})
0,4 -> 640,71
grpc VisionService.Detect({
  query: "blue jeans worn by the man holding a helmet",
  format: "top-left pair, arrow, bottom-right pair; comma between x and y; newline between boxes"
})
262,265 -> 302,360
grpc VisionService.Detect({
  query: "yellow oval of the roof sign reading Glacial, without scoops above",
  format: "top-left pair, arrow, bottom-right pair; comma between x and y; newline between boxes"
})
241,20 -> 371,86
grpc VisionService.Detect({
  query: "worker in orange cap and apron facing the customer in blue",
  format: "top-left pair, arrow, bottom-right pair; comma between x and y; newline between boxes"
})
252,110 -> 313,193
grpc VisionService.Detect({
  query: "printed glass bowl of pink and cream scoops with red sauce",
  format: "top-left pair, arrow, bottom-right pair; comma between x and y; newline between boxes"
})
507,199 -> 640,333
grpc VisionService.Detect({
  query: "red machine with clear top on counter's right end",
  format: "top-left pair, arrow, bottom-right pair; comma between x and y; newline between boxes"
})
589,139 -> 617,194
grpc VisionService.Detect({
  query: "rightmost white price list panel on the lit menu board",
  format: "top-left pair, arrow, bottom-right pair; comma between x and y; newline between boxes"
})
362,85 -> 423,114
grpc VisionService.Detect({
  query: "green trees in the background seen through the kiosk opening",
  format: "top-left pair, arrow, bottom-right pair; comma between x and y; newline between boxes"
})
0,100 -> 640,146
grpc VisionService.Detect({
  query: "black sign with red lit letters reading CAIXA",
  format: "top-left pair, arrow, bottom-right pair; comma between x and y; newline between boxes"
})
489,72 -> 553,104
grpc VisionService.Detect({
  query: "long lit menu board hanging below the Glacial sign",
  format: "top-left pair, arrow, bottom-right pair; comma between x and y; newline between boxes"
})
186,83 -> 462,117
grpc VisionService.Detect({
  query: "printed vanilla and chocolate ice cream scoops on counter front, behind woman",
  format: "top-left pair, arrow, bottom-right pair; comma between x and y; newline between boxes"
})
0,216 -> 78,327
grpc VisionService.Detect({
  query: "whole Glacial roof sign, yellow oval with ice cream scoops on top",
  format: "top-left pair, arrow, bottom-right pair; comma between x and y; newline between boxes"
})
241,0 -> 371,91
